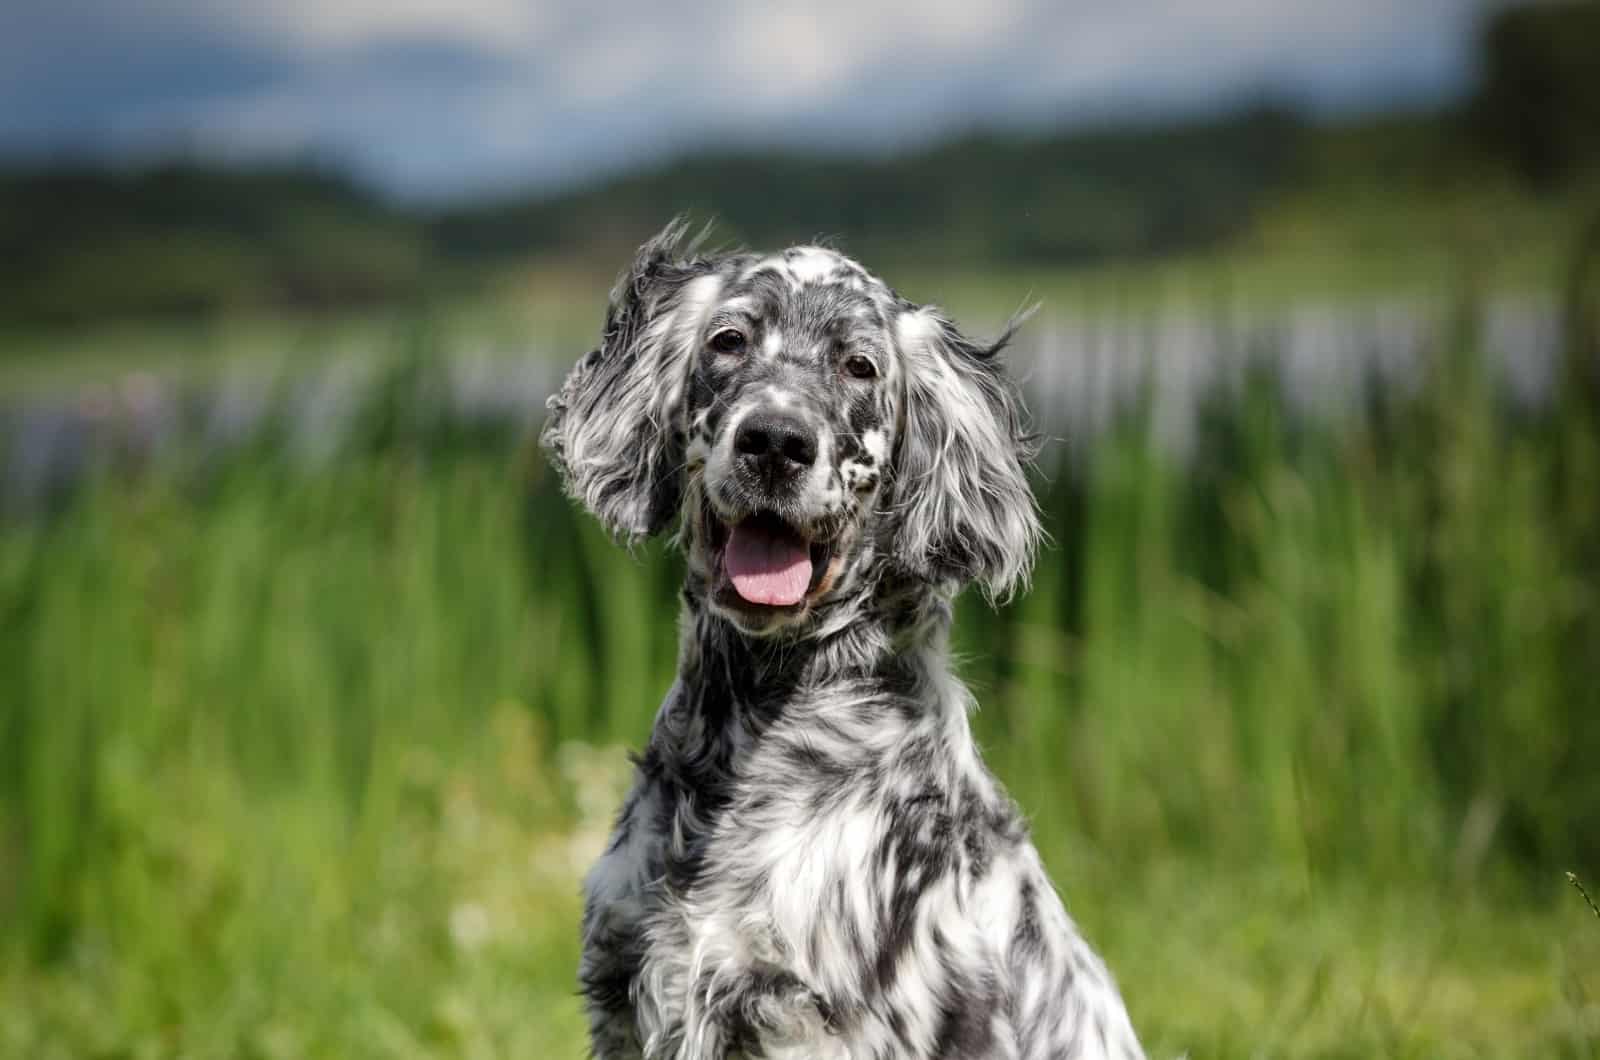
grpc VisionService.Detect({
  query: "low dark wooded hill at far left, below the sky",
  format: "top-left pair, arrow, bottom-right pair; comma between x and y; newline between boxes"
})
0,163 -> 426,323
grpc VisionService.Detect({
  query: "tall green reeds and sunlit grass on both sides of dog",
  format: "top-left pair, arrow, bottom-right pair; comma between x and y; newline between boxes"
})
0,270 -> 1600,1060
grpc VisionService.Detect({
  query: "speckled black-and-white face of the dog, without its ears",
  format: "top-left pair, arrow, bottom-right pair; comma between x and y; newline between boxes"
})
685,248 -> 902,632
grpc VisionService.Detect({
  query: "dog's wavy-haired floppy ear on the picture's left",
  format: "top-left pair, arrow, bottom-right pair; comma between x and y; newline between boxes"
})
541,219 -> 722,543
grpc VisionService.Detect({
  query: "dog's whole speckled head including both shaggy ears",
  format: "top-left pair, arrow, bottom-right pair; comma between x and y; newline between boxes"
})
544,224 -> 1040,634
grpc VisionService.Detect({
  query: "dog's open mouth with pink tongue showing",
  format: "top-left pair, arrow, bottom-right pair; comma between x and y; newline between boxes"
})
706,511 -> 830,610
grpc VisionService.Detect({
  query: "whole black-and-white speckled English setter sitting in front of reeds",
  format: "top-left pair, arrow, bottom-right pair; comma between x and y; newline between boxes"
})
544,224 -> 1142,1060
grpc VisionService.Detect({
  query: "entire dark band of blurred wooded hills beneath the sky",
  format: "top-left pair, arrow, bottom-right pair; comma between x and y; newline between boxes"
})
0,107 -> 1548,325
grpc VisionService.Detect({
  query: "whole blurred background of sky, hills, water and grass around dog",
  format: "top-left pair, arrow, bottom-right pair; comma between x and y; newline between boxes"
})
0,0 -> 1600,1060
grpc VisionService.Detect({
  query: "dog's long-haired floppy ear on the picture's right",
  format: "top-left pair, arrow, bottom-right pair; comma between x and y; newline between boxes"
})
890,306 -> 1043,602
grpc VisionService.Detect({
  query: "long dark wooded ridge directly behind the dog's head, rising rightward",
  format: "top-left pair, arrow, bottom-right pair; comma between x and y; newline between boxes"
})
434,109 -> 1310,264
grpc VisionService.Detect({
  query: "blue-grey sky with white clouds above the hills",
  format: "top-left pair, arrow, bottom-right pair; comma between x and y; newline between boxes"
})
0,0 -> 1493,197
